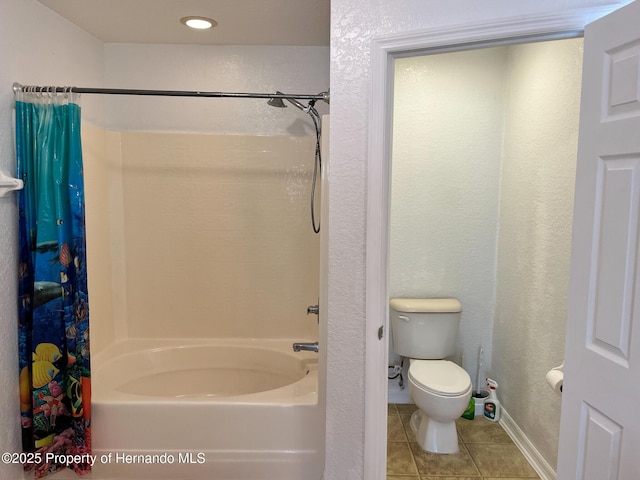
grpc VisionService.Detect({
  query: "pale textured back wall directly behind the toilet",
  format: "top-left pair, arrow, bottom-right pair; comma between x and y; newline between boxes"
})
389,47 -> 507,390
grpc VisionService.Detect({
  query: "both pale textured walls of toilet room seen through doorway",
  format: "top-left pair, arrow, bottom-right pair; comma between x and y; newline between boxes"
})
389,38 -> 583,473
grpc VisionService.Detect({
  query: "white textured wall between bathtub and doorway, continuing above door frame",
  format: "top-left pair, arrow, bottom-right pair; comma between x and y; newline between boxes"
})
325,0 -> 625,480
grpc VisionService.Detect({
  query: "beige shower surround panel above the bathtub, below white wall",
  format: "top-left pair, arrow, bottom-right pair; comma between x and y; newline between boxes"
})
85,126 -> 319,343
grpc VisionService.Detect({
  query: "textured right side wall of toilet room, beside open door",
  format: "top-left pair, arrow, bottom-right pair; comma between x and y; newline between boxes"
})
493,39 -> 582,468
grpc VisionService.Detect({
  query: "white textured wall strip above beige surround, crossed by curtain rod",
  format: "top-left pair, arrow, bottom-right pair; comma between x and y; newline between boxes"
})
105,44 -> 329,136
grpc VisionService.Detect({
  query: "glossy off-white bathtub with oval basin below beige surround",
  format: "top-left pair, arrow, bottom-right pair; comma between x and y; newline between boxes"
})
92,339 -> 324,480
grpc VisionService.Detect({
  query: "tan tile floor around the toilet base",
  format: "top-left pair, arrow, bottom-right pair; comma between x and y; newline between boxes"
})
387,404 -> 540,480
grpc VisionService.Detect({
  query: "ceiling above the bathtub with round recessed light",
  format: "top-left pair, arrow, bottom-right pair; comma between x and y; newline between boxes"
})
38,0 -> 330,46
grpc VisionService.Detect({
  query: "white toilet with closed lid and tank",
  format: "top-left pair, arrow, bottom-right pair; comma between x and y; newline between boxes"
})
389,298 -> 472,453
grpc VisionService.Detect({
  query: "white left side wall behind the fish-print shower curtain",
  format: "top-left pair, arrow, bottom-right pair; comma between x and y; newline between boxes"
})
0,0 -> 103,480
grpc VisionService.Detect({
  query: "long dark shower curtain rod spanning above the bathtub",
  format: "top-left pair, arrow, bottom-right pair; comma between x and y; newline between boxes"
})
13,83 -> 329,103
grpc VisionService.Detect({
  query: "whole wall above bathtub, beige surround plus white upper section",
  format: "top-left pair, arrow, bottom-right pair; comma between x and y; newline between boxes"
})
83,44 -> 329,349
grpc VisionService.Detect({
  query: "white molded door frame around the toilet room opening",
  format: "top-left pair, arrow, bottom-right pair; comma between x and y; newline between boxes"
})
364,3 -> 623,480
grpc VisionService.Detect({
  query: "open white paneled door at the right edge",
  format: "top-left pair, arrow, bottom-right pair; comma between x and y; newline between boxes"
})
556,1 -> 640,480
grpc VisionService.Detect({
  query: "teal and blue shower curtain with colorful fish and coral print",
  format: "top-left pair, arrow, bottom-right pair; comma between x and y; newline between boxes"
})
16,89 -> 91,478
